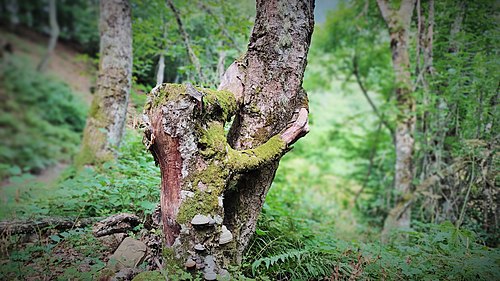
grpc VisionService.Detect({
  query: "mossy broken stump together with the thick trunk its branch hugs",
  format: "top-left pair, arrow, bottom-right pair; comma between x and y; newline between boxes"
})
145,0 -> 314,280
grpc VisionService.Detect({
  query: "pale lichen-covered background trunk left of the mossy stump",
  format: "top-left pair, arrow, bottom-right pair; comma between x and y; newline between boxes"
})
75,0 -> 132,166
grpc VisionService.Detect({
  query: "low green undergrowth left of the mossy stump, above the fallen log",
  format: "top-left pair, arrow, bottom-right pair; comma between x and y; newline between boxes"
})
14,130 -> 160,217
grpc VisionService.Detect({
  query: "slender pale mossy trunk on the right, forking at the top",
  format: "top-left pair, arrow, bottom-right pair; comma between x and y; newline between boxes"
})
377,0 -> 416,240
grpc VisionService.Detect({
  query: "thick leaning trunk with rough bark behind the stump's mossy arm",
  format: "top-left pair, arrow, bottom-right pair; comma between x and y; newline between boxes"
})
219,0 -> 314,262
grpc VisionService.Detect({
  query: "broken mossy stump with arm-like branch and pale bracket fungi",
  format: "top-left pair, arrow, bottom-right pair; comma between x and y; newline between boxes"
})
144,84 -> 308,280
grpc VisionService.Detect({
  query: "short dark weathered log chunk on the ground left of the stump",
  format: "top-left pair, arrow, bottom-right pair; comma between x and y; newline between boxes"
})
92,213 -> 139,237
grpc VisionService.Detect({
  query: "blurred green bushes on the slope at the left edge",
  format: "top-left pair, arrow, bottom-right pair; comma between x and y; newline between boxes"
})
0,57 -> 86,179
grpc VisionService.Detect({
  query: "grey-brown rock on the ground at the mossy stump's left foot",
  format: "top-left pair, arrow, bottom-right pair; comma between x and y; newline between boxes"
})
108,237 -> 147,270
